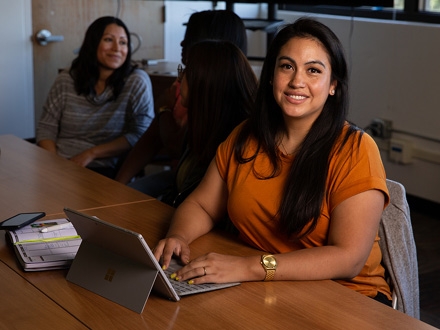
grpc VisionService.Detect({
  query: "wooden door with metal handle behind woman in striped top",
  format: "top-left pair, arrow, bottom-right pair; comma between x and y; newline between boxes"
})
32,0 -> 164,131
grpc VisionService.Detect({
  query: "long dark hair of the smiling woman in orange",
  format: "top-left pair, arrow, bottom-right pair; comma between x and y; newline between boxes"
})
235,18 -> 362,236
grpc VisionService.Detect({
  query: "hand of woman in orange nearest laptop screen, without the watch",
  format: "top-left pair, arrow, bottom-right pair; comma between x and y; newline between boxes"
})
153,235 -> 190,270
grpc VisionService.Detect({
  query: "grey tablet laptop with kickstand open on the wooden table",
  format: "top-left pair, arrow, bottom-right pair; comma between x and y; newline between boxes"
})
64,208 -> 240,313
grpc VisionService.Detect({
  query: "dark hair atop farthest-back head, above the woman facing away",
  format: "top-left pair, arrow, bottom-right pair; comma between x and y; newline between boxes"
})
181,10 -> 247,64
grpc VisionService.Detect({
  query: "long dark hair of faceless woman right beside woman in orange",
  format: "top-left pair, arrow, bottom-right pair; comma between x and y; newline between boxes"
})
185,40 -> 257,165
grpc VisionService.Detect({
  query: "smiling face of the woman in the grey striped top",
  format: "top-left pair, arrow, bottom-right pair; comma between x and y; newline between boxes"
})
97,24 -> 129,70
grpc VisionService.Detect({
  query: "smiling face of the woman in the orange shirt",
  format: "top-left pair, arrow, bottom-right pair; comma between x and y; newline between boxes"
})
273,37 -> 336,126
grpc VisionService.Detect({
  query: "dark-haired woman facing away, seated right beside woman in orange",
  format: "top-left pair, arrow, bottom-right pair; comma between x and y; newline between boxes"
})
159,40 -> 257,206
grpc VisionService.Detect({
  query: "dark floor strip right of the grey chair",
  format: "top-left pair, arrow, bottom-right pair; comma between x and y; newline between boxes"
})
408,196 -> 440,329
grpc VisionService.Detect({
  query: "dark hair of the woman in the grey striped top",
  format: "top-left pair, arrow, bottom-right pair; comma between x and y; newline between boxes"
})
69,16 -> 134,99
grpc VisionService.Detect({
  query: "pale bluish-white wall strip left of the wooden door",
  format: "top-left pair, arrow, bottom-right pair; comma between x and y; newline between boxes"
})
0,0 -> 35,138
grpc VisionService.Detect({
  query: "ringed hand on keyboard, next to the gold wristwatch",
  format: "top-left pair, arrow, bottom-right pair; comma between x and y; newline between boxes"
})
172,253 -> 264,284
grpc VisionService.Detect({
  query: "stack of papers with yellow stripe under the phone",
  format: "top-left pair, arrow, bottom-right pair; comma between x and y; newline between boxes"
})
8,219 -> 81,271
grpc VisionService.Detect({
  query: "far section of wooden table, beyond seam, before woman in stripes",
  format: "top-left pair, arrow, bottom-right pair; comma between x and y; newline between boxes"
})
0,135 -> 153,219
